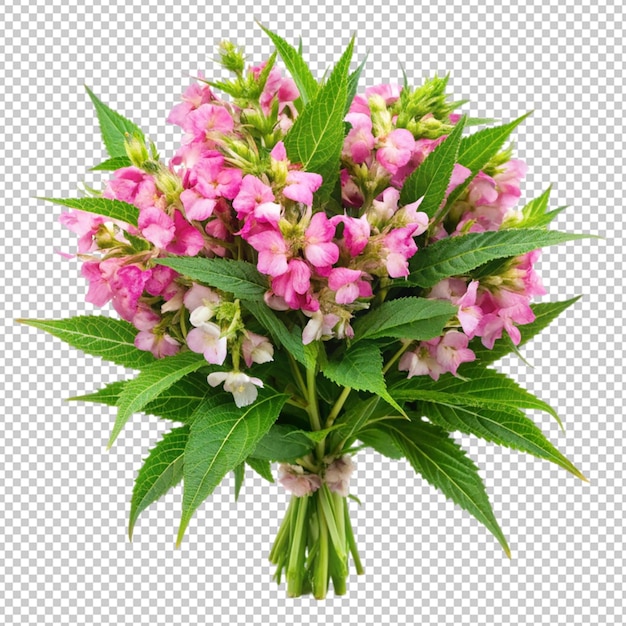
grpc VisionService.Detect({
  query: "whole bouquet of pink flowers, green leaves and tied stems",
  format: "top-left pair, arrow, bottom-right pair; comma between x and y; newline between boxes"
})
22,30 -> 584,598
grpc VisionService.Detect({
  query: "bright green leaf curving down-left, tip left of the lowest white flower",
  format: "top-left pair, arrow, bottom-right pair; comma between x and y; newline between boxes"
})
107,352 -> 207,449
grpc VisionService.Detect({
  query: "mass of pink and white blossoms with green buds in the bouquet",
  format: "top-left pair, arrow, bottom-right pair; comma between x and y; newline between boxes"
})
61,48 -> 543,405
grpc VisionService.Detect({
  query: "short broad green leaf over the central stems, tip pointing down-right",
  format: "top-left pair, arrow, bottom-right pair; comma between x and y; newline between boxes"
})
322,341 -> 404,414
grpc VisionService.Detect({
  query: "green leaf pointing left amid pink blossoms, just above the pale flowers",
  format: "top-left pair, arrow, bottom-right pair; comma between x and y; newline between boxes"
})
156,257 -> 269,300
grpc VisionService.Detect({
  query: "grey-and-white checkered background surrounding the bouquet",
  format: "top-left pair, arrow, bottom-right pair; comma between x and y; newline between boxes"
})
0,0 -> 626,626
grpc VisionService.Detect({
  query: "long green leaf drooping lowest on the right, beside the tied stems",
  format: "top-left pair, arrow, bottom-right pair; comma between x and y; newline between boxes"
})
384,421 -> 511,558
